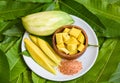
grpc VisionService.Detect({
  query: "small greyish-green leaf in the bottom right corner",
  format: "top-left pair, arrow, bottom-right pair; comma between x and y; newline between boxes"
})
109,63 -> 120,83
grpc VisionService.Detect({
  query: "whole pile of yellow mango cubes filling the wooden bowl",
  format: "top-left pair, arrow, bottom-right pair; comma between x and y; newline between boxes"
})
56,27 -> 85,55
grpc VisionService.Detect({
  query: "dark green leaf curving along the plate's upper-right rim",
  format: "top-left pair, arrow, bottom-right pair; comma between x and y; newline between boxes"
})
59,0 -> 105,36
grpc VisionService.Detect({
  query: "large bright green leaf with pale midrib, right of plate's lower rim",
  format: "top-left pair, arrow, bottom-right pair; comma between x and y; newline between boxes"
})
76,39 -> 120,83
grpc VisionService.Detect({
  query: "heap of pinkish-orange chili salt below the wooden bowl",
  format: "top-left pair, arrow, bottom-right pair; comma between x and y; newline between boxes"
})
59,60 -> 82,75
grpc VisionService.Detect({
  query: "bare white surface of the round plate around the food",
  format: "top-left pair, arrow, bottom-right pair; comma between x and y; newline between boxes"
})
21,15 -> 99,81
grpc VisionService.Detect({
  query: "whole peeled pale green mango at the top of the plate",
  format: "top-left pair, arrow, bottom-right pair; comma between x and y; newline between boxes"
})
22,11 -> 74,36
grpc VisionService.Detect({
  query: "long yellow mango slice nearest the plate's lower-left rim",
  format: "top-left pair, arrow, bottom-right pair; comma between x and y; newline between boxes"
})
24,38 -> 56,74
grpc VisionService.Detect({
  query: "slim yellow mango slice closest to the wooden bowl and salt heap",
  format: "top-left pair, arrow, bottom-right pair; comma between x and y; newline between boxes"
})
37,38 -> 60,65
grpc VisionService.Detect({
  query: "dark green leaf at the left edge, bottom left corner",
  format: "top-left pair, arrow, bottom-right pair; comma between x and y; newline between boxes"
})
0,50 -> 10,83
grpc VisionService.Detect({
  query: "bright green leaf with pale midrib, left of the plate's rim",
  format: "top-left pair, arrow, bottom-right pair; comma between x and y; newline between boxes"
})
6,38 -> 26,81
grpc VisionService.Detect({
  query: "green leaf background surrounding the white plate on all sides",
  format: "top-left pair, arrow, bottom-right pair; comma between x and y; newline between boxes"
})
0,0 -> 120,83
